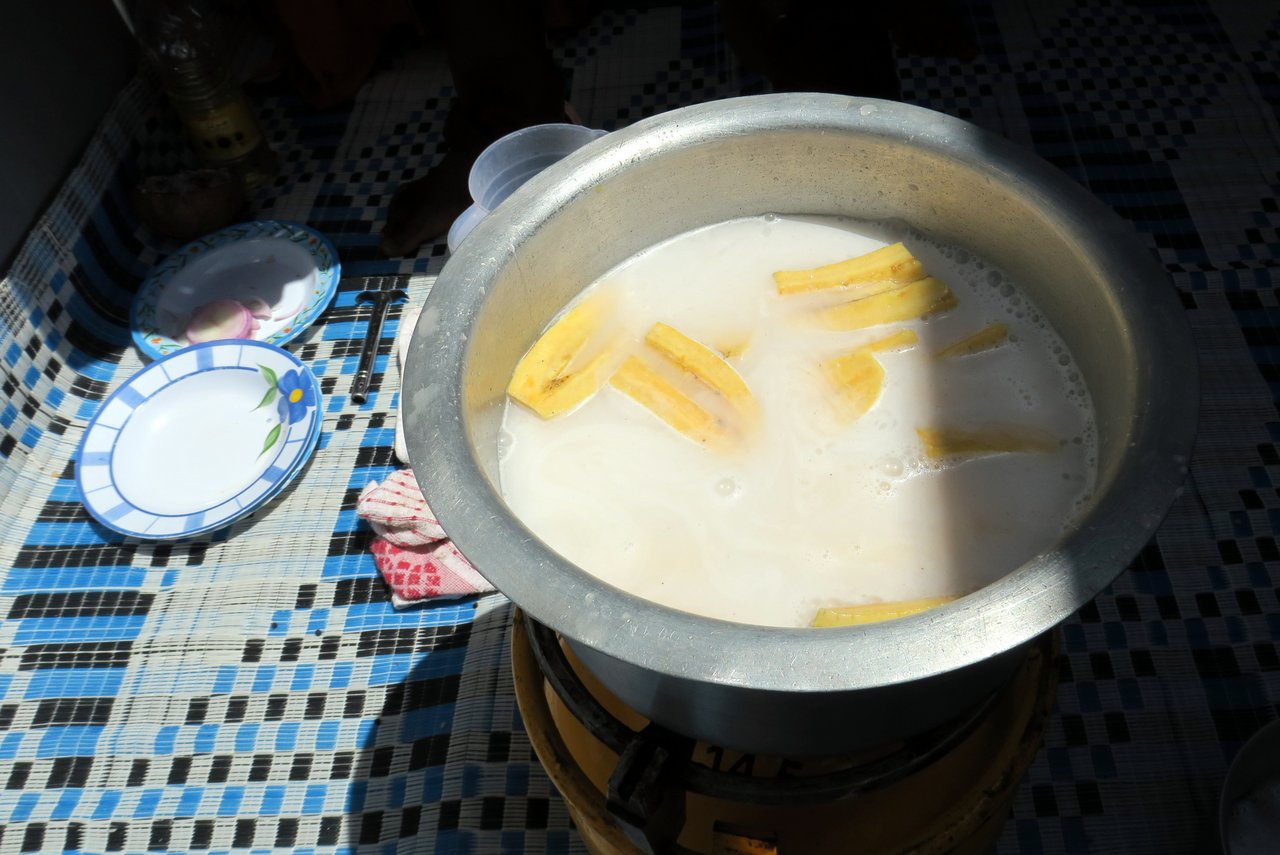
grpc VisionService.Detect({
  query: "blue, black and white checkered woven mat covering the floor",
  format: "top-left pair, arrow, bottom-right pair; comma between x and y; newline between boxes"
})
0,0 -> 1280,855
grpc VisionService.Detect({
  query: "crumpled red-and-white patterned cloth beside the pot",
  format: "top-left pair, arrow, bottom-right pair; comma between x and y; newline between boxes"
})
356,468 -> 494,608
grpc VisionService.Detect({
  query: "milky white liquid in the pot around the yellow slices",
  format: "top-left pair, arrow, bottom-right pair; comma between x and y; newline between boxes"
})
500,215 -> 1094,626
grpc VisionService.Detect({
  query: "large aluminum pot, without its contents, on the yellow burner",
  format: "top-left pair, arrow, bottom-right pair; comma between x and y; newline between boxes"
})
402,95 -> 1197,755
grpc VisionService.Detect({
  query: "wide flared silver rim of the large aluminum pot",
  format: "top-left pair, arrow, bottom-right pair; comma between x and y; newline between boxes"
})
402,93 -> 1198,692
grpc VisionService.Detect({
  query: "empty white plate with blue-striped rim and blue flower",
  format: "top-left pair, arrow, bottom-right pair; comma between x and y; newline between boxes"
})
76,340 -> 323,539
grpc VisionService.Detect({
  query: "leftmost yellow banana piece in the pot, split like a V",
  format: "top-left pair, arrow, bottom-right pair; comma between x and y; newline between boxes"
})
507,294 -> 618,419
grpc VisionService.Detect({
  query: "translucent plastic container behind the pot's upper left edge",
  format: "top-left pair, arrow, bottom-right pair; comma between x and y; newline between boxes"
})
448,124 -> 607,252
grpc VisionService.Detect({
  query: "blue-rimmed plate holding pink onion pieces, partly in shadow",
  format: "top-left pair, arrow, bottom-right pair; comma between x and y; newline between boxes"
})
129,220 -> 340,358
